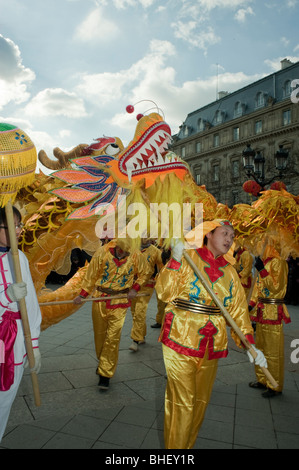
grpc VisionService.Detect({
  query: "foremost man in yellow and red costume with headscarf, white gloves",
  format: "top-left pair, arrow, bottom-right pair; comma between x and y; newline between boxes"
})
156,220 -> 266,449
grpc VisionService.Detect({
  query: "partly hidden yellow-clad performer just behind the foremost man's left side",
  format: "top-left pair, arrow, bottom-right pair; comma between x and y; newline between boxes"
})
129,239 -> 163,352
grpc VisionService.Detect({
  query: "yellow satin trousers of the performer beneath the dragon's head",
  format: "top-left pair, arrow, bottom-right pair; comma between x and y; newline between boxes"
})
92,302 -> 127,378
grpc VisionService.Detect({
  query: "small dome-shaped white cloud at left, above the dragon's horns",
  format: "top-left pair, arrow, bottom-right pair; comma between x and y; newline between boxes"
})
25,88 -> 87,119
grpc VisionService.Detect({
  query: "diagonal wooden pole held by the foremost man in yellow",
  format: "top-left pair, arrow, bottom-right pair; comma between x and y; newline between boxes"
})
184,251 -> 278,388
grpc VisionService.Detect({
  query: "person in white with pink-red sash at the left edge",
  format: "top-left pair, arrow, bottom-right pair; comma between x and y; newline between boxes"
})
0,207 -> 41,442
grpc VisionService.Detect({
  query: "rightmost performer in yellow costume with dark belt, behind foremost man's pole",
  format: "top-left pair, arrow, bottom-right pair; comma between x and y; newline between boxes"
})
249,245 -> 291,398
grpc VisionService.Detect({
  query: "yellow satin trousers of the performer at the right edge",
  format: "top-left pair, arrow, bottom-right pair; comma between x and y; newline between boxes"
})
255,323 -> 284,392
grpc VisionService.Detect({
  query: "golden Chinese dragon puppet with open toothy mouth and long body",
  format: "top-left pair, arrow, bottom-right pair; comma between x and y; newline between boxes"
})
10,113 -> 299,329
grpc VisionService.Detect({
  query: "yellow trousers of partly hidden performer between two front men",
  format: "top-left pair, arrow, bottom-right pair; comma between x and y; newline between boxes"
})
131,287 -> 154,341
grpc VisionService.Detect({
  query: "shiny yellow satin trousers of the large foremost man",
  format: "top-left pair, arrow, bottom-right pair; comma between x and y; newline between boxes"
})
162,344 -> 218,449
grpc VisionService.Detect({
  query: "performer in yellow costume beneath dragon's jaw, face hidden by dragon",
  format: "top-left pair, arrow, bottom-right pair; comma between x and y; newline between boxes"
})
74,240 -> 150,390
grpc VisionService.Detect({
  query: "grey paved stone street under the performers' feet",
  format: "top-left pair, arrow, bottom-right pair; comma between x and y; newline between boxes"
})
0,288 -> 299,449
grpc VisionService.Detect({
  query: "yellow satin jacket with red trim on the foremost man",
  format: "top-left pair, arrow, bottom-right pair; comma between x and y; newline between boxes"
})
156,247 -> 254,359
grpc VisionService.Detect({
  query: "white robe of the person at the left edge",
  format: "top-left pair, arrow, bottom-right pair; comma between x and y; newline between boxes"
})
0,250 -> 42,442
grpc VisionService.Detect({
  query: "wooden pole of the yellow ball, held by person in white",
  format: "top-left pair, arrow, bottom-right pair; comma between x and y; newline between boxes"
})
5,201 -> 41,406
